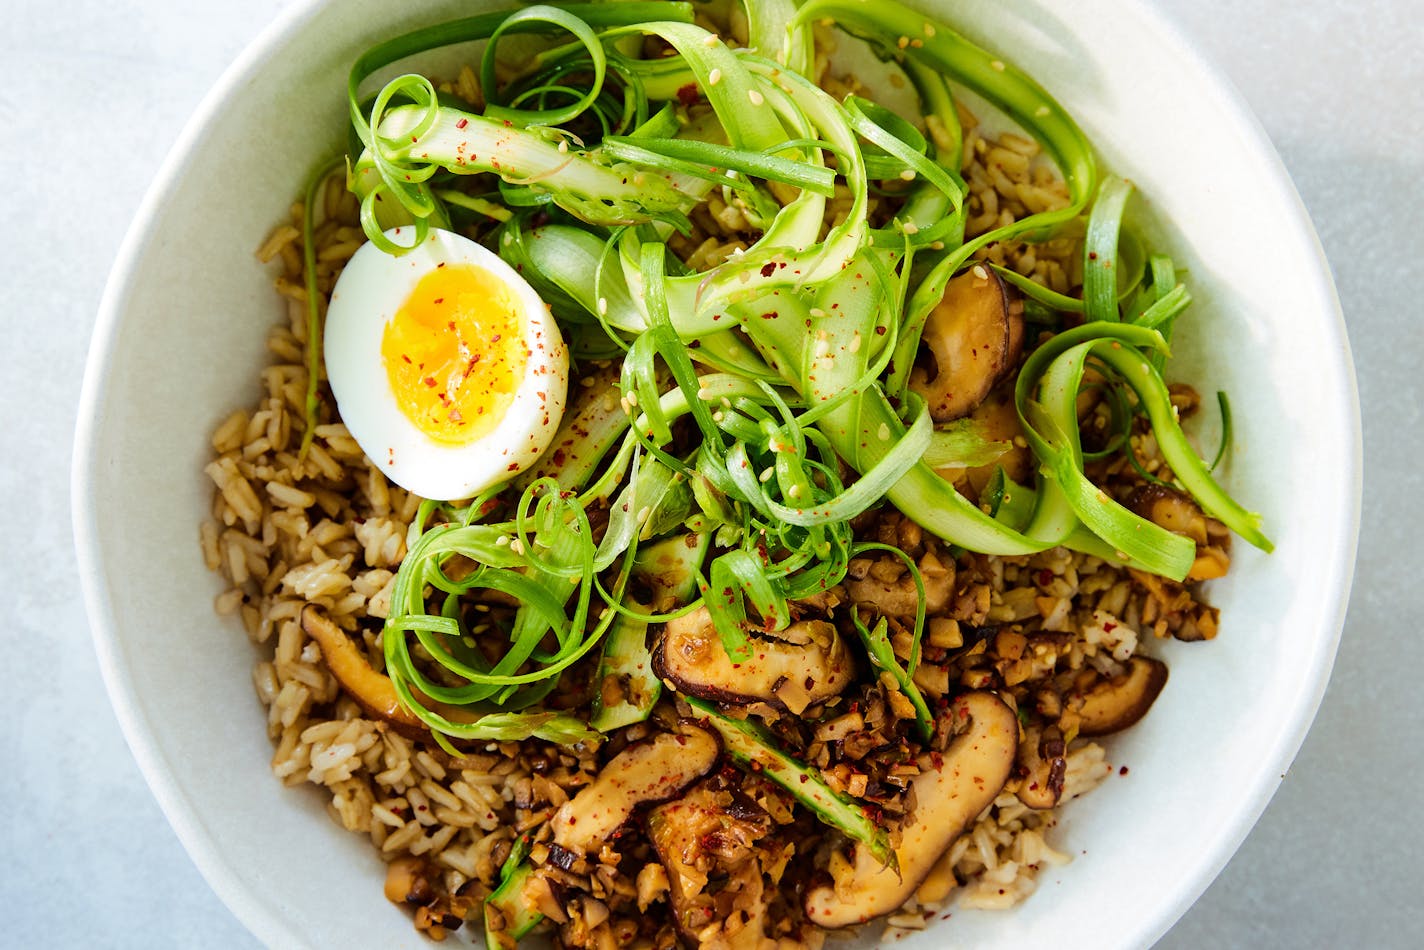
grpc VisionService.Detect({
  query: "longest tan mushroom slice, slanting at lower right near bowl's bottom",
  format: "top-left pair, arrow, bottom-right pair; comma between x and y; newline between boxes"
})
806,691 -> 1018,929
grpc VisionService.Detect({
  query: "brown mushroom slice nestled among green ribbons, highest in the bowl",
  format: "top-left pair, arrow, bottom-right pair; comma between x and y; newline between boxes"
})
910,263 -> 1024,422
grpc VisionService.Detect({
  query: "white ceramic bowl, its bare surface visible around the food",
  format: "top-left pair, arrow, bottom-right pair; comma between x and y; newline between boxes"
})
74,0 -> 1360,947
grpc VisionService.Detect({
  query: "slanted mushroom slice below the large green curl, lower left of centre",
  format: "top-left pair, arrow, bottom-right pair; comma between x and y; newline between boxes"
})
550,722 -> 722,855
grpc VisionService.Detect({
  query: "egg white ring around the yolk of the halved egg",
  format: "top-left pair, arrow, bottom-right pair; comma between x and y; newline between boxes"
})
323,228 -> 568,500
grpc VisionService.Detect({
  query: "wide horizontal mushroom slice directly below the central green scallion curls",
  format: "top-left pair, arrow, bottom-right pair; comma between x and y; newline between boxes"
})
652,607 -> 856,714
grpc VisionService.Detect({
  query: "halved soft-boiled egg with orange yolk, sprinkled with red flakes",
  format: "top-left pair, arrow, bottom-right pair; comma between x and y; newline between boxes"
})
323,228 -> 568,501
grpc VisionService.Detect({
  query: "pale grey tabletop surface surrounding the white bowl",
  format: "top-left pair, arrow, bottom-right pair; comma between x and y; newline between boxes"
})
0,0 -> 1424,949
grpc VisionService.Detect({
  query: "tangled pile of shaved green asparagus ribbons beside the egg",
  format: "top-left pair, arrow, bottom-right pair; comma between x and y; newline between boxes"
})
323,0 -> 1270,742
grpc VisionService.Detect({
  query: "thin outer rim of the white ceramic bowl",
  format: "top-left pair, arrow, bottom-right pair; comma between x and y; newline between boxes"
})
70,0 -> 1363,946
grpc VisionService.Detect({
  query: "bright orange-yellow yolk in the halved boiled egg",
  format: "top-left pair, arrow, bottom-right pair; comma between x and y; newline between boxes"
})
380,263 -> 528,444
